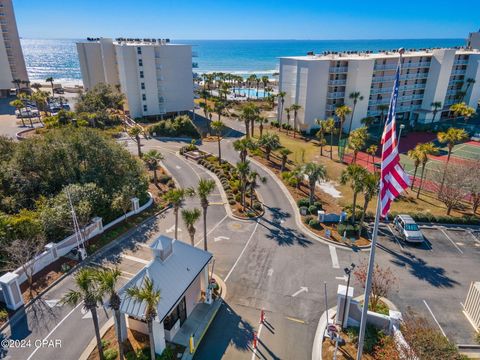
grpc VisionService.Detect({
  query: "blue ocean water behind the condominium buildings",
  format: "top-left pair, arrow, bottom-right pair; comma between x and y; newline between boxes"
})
21,38 -> 465,84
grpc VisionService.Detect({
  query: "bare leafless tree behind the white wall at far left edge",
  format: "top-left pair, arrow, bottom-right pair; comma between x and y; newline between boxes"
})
4,235 -> 45,298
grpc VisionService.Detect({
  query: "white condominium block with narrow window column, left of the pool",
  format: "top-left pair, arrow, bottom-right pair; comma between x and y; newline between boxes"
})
77,38 -> 193,118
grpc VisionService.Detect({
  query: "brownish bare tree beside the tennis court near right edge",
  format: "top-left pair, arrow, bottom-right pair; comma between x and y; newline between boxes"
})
437,164 -> 471,215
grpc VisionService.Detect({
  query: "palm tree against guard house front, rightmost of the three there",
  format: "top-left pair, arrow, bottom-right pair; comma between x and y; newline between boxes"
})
127,275 -> 161,360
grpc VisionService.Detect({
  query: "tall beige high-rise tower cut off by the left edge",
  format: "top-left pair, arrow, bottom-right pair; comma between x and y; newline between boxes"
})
0,0 -> 28,96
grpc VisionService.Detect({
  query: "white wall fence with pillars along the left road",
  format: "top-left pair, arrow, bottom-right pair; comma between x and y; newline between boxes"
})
0,193 -> 153,310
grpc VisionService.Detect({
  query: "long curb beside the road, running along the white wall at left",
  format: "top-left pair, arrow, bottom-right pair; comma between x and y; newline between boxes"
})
0,203 -> 171,332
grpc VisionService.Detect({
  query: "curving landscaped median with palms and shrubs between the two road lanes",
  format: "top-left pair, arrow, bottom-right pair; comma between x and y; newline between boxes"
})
180,143 -> 265,219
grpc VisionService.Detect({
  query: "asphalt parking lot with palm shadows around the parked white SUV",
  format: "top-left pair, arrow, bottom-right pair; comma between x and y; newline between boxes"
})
377,225 -> 480,344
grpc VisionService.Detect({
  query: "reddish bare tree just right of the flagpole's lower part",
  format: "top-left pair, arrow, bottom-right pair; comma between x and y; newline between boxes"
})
354,261 -> 397,311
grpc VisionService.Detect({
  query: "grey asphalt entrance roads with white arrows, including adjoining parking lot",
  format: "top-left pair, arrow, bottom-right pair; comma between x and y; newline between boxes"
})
3,111 -> 480,360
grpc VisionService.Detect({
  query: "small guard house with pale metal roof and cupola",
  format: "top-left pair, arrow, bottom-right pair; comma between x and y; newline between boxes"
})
119,235 -> 214,354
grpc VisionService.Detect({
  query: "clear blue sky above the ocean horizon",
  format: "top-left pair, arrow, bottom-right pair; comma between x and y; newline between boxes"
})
13,0 -> 480,40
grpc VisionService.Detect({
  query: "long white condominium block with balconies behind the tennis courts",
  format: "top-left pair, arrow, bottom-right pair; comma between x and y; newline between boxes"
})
279,32 -> 480,130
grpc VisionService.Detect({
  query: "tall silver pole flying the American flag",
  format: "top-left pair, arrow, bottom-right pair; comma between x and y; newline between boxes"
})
357,49 -> 404,360
